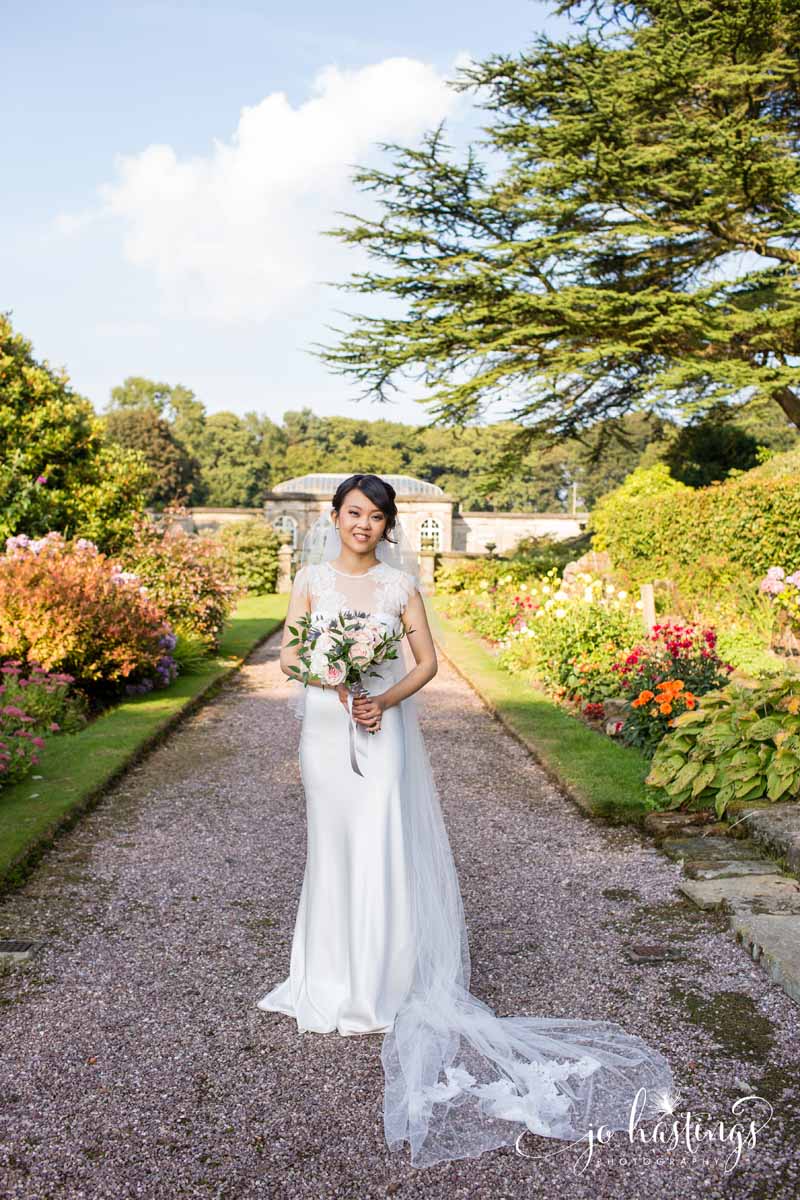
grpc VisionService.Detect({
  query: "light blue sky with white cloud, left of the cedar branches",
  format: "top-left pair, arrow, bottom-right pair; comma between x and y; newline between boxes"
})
0,0 -> 575,425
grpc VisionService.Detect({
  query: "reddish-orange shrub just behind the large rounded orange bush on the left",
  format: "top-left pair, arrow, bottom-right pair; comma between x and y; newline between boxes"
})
125,510 -> 240,650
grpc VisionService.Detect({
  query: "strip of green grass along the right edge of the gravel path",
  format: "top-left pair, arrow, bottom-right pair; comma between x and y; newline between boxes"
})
426,596 -> 649,822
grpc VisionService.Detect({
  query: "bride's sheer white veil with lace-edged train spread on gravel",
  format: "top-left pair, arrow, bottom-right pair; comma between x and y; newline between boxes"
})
287,518 -> 673,1166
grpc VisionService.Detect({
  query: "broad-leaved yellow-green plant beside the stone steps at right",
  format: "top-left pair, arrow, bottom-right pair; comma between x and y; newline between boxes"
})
645,676 -> 800,817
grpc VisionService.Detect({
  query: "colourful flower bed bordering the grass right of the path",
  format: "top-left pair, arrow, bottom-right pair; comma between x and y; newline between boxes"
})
434,564 -> 800,812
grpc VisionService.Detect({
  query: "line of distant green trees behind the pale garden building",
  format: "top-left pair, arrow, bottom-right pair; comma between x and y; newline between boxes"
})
102,377 -> 800,511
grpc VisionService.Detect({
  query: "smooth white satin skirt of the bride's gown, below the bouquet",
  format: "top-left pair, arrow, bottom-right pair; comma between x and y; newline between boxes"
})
257,665 -> 414,1037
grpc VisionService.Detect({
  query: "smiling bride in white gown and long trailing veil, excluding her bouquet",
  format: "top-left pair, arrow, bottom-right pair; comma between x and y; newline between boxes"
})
257,474 -> 673,1166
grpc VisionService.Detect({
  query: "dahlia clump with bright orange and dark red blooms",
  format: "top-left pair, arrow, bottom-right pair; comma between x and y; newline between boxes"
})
613,622 -> 733,754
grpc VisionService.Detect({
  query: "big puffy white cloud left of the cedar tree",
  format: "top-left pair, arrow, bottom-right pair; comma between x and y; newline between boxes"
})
56,58 -> 463,323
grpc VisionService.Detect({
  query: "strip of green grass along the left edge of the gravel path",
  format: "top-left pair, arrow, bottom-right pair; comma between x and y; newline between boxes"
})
0,595 -> 289,890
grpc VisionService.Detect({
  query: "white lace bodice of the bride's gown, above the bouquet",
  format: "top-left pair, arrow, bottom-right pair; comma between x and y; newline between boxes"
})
294,563 -> 416,626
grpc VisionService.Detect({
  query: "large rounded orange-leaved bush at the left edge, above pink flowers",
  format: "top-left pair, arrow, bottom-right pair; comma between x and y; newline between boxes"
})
0,532 -> 173,697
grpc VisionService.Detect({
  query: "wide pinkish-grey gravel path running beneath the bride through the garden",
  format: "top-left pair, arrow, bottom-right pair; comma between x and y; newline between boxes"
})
0,635 -> 800,1200
